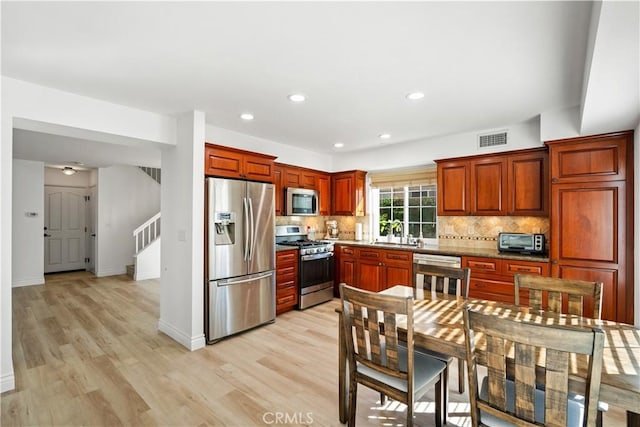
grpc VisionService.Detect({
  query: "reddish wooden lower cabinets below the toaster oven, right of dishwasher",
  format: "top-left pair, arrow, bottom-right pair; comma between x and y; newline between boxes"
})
462,256 -> 549,305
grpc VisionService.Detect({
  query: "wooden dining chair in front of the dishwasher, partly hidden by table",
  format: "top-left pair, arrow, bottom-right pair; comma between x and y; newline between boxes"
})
413,263 -> 471,393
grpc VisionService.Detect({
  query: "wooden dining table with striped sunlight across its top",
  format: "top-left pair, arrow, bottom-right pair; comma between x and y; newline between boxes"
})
336,285 -> 640,427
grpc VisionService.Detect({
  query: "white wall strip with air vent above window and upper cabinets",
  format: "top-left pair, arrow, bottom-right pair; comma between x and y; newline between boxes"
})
333,118 -> 542,171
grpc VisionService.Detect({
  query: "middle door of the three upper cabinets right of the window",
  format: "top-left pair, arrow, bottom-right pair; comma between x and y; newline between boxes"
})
470,156 -> 507,216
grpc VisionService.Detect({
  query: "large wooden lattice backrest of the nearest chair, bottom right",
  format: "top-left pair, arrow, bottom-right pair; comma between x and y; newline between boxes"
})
463,308 -> 604,426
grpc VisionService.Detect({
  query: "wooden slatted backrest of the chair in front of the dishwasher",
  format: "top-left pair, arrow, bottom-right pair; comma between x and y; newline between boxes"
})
413,262 -> 471,298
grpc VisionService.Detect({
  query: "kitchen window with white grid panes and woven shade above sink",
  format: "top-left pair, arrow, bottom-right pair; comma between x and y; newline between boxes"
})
369,165 -> 438,241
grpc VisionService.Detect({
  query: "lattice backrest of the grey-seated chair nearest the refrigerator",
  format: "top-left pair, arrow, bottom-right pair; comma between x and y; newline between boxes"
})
340,283 -> 413,384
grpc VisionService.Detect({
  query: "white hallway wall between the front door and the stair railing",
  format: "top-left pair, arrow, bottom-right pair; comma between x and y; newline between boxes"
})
95,166 -> 160,277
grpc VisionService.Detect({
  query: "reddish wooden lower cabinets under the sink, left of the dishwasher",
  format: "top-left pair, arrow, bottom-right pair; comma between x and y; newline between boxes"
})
336,245 -> 413,295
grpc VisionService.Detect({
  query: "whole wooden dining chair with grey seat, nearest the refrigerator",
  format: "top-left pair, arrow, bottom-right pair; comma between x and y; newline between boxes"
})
340,283 -> 447,427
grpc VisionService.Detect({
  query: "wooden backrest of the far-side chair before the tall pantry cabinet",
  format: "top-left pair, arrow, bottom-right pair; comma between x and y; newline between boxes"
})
514,274 -> 602,319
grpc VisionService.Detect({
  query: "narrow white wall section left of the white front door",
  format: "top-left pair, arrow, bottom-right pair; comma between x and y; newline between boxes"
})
11,159 -> 45,287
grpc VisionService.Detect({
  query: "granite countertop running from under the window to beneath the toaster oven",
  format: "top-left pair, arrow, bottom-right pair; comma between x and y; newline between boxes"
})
332,240 -> 549,262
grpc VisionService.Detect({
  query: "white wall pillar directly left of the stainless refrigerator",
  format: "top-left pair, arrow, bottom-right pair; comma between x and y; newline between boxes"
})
158,111 -> 205,350
